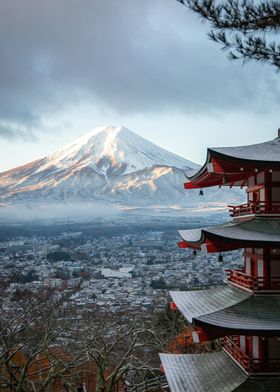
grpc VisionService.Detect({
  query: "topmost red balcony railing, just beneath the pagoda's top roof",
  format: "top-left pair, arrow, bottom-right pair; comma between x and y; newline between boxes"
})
228,202 -> 280,218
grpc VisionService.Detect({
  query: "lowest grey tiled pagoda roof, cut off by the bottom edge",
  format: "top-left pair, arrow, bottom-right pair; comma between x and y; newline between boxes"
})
160,351 -> 280,392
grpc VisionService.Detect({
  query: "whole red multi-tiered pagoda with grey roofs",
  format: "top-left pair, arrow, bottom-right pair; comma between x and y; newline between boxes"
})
160,132 -> 280,392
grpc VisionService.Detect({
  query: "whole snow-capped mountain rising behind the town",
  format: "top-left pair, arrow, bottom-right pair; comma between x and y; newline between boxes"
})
0,126 -> 244,210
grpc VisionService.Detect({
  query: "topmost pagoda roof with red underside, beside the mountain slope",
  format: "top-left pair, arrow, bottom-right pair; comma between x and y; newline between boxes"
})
185,137 -> 280,189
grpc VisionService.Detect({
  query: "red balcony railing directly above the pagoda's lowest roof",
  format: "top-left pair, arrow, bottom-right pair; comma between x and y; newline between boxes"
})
223,337 -> 280,373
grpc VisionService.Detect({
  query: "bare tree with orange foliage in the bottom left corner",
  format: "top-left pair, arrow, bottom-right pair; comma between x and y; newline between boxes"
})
0,289 -> 84,392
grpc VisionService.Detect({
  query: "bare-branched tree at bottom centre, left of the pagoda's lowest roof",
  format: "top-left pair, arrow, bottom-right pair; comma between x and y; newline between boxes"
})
78,315 -> 156,392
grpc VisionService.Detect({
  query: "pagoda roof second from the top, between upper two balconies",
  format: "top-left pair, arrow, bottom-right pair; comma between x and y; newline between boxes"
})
179,217 -> 280,252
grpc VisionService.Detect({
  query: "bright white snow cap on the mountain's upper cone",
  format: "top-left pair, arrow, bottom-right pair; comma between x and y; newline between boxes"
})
35,126 -> 198,176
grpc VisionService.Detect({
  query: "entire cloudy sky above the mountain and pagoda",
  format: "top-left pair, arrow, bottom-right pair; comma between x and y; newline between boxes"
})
0,0 -> 280,171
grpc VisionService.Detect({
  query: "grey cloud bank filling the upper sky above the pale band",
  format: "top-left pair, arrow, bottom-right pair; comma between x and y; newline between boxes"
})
0,0 -> 279,136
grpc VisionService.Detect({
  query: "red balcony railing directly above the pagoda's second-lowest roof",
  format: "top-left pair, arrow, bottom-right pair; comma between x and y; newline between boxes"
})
225,269 -> 280,291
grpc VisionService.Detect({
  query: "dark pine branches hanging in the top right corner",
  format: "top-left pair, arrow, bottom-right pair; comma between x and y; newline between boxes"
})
177,0 -> 280,70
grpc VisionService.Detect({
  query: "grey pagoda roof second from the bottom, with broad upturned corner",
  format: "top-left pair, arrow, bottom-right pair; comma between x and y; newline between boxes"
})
170,285 -> 280,335
